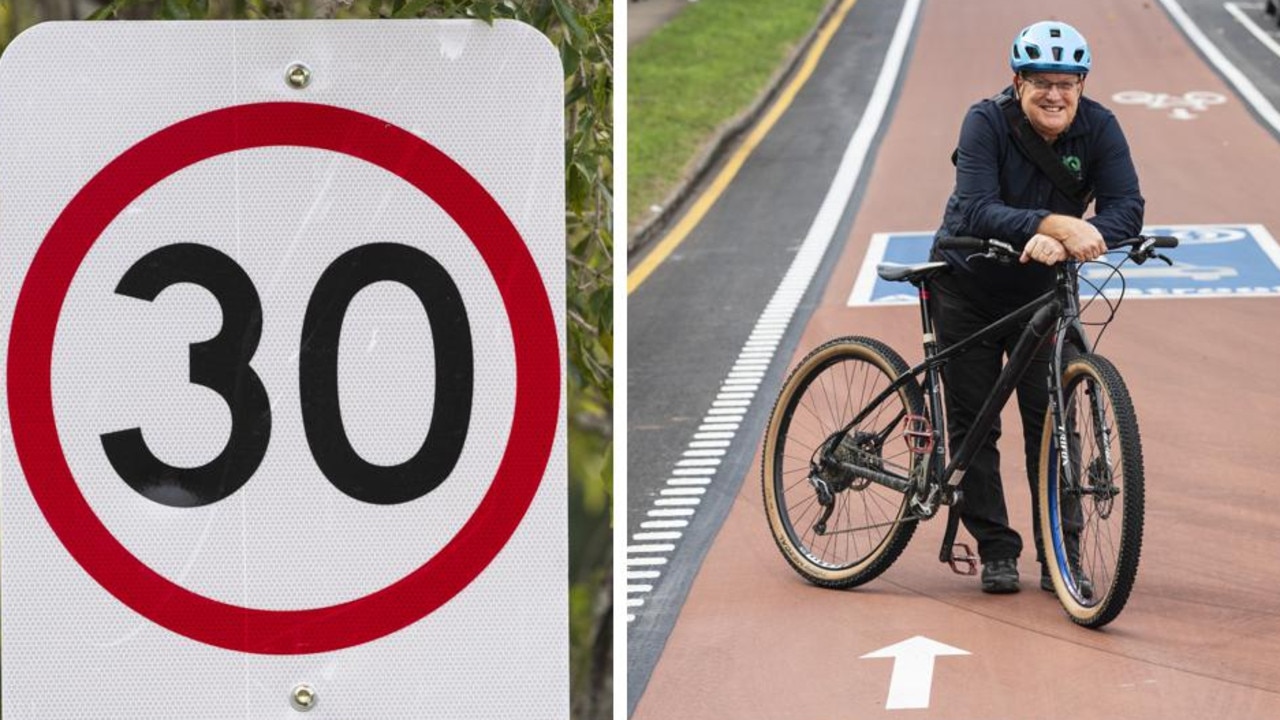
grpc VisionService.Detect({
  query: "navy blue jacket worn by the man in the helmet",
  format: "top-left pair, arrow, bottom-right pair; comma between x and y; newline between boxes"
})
936,86 -> 1144,300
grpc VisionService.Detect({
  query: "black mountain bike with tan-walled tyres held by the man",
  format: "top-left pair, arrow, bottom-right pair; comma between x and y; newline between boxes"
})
762,236 -> 1178,628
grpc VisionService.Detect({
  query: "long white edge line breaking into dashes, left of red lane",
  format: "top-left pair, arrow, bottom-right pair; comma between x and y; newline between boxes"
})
627,0 -> 920,623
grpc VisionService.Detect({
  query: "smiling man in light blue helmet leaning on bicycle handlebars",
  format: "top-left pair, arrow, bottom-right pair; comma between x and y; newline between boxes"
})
931,20 -> 1143,593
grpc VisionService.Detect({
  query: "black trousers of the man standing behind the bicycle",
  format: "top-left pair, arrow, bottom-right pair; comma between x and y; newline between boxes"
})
929,270 -> 1051,562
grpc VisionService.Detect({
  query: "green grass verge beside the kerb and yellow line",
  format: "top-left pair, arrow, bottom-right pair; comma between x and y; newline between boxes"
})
627,0 -> 828,233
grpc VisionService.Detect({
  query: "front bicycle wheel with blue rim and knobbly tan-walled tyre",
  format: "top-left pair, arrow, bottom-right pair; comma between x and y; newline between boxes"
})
1038,355 -> 1143,628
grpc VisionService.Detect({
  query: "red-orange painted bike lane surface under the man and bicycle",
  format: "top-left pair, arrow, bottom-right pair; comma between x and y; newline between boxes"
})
634,0 -> 1280,720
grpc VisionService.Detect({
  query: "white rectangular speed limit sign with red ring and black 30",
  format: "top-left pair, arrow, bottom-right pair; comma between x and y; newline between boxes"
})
0,20 -> 568,720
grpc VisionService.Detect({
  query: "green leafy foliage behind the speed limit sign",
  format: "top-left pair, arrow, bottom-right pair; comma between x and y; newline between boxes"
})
0,0 -> 613,719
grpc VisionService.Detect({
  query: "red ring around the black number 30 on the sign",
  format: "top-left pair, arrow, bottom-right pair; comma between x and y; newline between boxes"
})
8,102 -> 561,655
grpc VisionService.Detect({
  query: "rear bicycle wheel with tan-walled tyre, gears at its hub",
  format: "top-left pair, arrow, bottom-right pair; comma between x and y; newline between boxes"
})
762,337 -> 924,588
